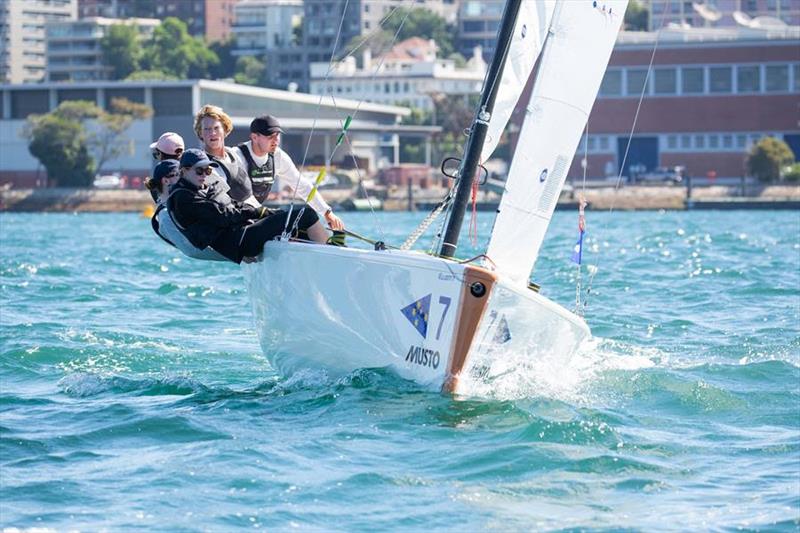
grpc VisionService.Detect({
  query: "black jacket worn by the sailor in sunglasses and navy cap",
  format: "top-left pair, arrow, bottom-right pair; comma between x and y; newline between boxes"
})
167,178 -> 260,263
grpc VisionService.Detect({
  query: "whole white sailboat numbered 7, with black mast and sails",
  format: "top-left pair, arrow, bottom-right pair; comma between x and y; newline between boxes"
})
243,0 -> 627,394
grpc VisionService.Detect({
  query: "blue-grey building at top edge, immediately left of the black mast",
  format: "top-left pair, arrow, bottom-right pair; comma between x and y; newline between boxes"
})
458,0 -> 505,60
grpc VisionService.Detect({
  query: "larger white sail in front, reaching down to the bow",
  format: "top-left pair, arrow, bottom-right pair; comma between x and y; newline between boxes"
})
486,0 -> 628,284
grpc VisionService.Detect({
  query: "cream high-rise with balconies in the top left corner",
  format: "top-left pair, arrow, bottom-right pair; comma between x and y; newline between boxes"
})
0,0 -> 78,83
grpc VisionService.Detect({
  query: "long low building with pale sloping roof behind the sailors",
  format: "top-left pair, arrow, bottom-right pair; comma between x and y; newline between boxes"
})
0,80 -> 440,187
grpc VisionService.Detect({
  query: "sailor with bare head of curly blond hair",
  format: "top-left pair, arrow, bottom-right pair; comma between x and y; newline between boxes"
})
194,105 -> 261,207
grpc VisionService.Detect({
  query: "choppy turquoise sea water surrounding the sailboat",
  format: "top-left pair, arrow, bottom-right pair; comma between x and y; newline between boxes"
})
0,212 -> 800,531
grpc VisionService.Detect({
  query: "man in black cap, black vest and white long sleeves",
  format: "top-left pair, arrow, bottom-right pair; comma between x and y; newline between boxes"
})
231,115 -> 344,231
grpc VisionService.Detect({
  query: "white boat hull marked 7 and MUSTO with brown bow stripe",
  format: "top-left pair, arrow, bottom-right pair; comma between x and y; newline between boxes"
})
244,241 -> 590,393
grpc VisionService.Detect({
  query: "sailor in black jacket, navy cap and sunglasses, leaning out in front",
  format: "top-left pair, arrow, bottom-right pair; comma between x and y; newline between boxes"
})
167,149 -> 328,263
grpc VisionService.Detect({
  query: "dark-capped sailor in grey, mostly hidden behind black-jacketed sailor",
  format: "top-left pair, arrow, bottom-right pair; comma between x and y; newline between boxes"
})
145,159 -> 227,261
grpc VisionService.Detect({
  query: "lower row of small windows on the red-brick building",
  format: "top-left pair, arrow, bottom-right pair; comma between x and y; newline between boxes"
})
577,132 -> 782,155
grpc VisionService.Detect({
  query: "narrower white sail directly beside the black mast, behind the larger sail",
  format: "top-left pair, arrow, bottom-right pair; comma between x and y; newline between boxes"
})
480,0 -> 556,163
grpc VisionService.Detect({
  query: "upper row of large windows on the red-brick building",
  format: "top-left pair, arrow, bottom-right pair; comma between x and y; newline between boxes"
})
599,63 -> 800,98
